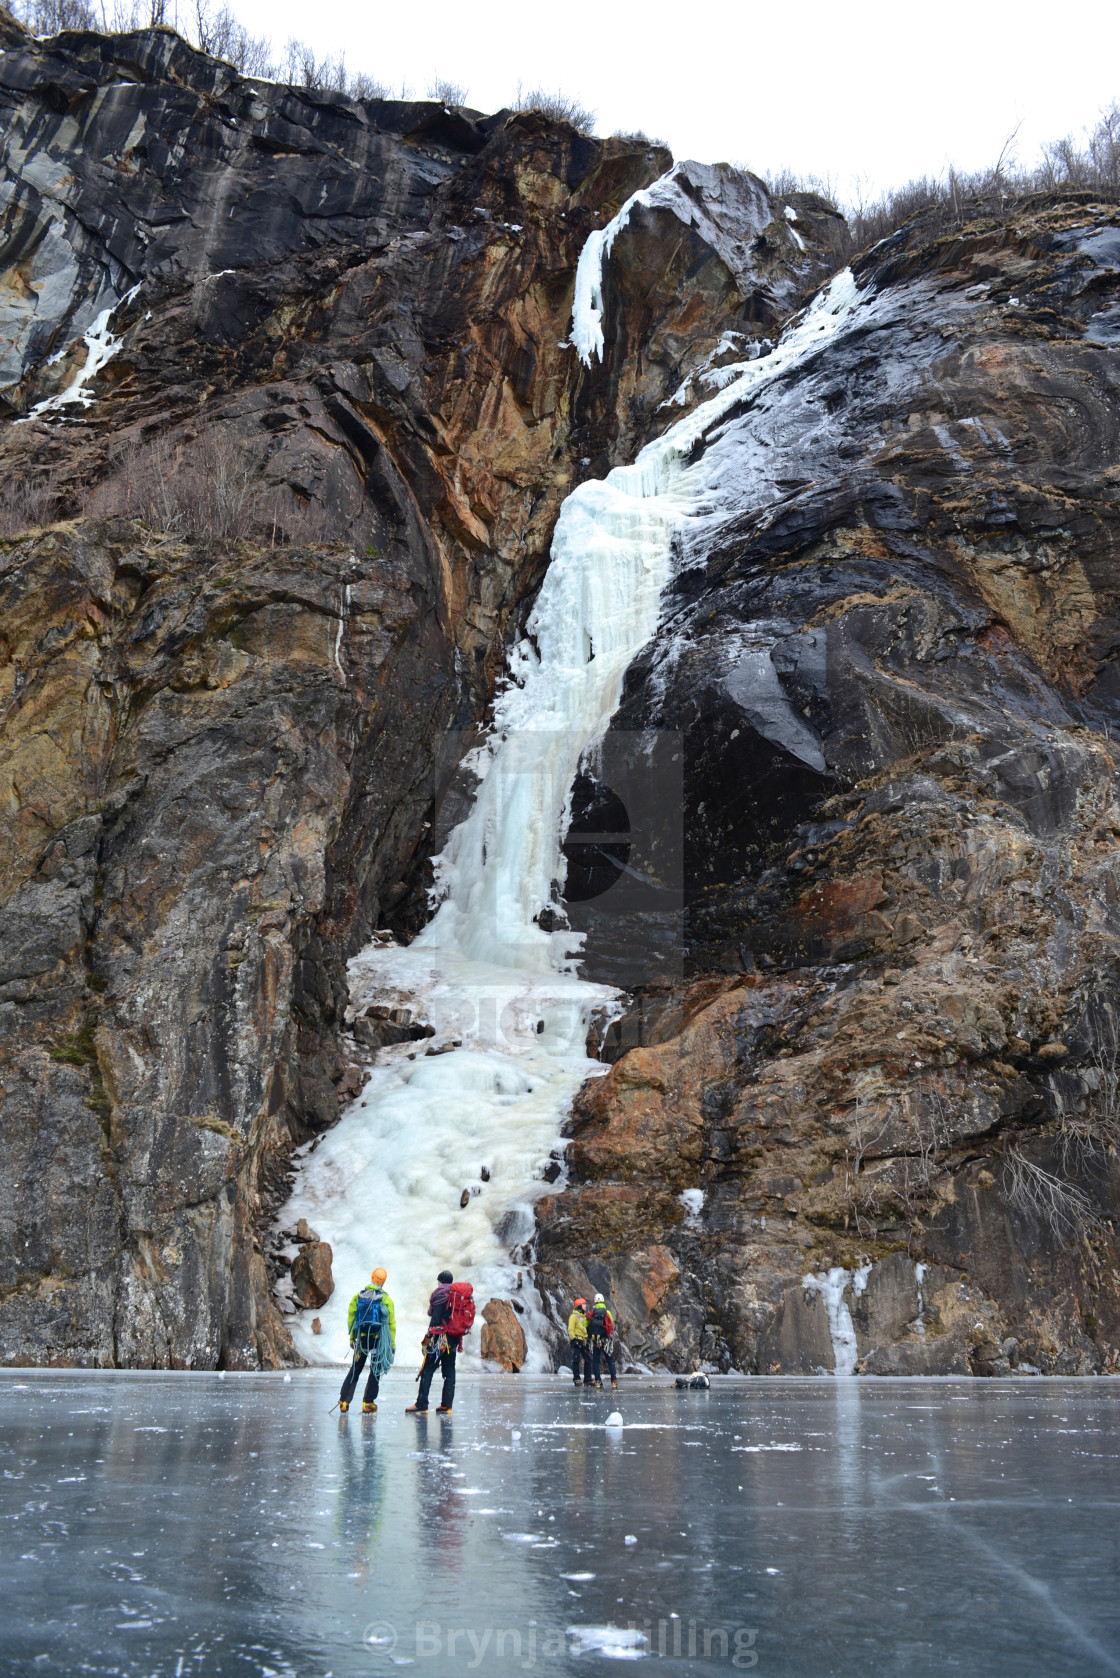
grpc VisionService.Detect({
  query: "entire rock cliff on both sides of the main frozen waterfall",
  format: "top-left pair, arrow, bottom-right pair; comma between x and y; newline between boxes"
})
0,20 -> 1120,1373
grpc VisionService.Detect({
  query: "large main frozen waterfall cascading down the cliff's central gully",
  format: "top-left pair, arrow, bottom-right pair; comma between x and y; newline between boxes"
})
279,258 -> 856,1368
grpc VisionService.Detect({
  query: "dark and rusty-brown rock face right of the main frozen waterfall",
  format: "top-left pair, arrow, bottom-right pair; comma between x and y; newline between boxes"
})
541,198 -> 1120,1374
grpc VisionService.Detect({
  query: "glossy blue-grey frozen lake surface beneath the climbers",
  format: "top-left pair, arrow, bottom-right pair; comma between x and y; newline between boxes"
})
0,1371 -> 1120,1678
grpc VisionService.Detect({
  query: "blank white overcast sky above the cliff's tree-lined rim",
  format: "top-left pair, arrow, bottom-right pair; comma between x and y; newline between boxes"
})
232,0 -> 1120,201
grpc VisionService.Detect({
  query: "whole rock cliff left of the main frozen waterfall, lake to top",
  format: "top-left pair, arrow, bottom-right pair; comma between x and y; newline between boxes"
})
0,13 -> 830,1368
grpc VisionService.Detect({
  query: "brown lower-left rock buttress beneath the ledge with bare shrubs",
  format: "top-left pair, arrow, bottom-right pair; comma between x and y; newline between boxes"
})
0,522 -> 438,1366
